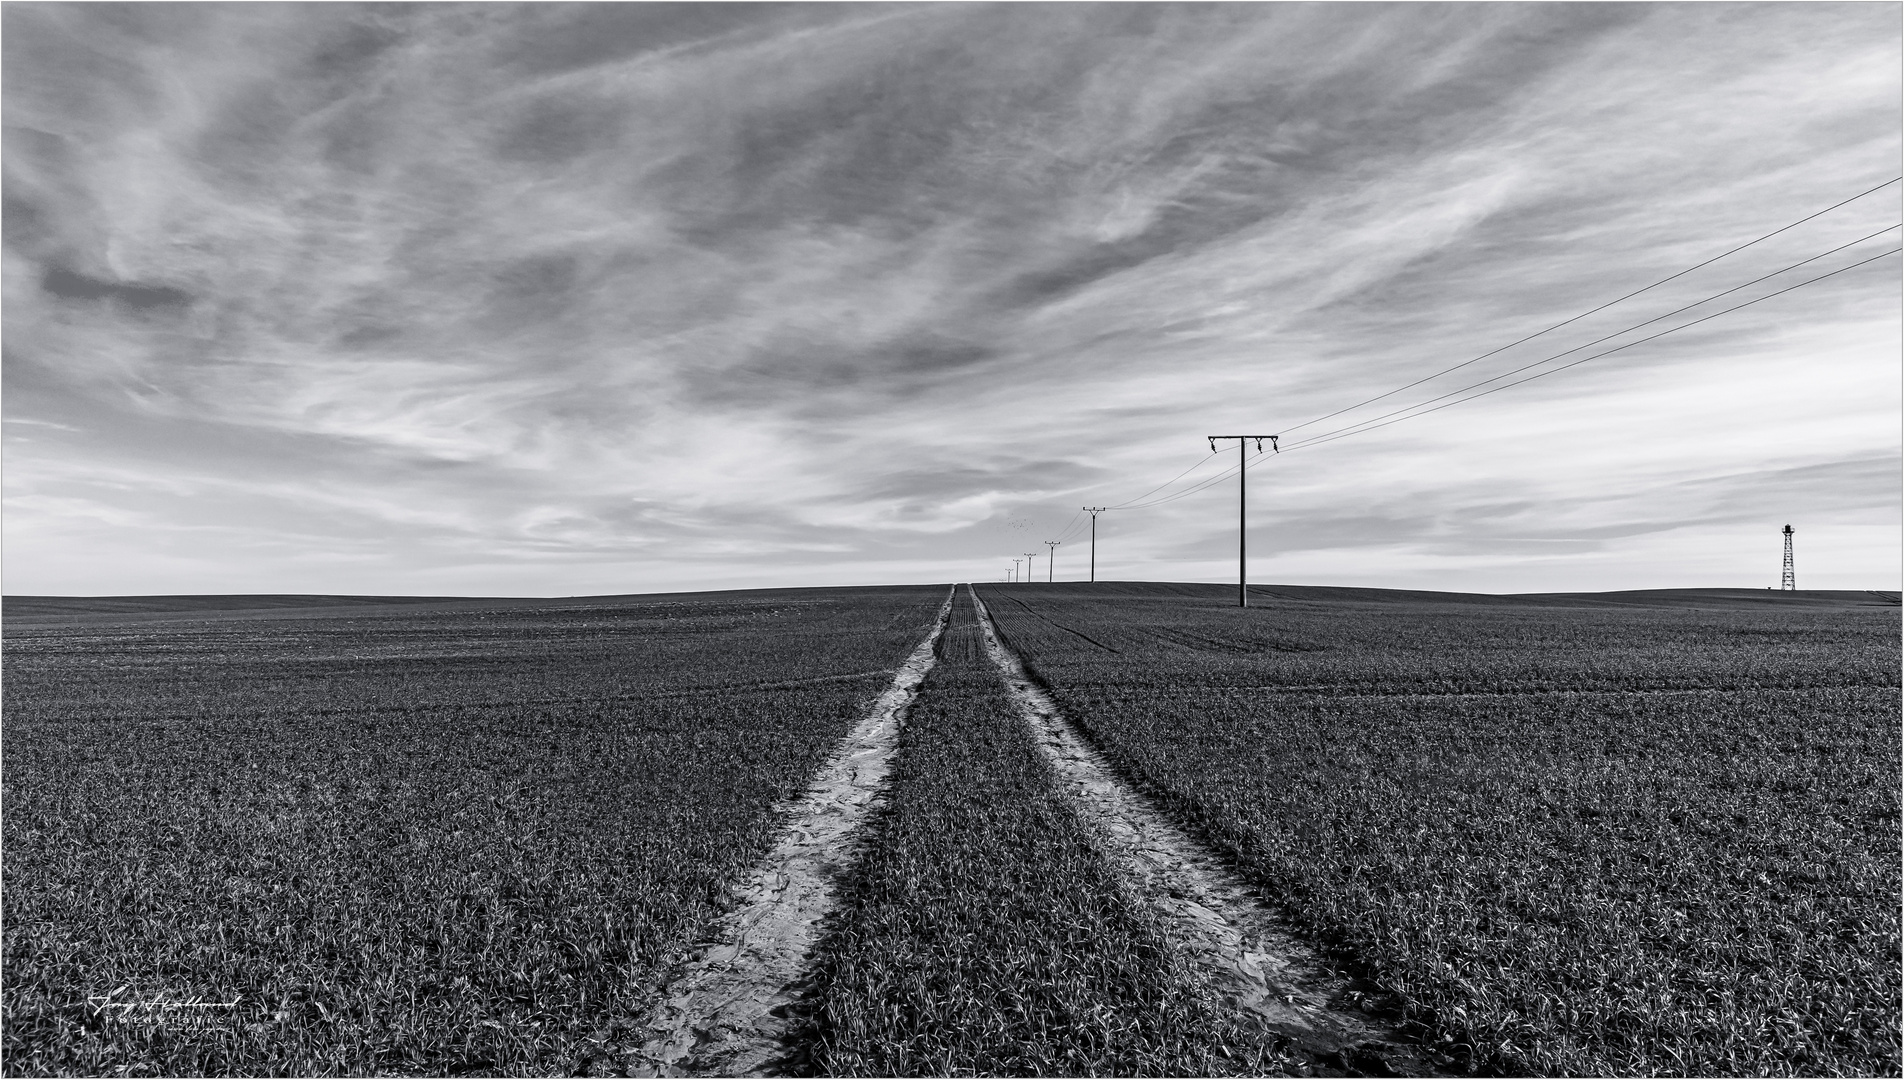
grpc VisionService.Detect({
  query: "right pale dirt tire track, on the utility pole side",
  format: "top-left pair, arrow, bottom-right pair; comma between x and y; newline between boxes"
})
965,585 -> 1438,1076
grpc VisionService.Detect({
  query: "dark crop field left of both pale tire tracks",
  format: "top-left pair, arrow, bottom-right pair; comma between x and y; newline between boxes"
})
0,589 -> 944,1074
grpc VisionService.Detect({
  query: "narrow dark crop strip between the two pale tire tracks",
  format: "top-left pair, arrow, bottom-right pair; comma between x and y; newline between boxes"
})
788,592 -> 1289,1076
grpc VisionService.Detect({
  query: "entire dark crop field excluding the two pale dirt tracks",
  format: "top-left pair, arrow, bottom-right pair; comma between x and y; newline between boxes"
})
0,583 -> 1904,1076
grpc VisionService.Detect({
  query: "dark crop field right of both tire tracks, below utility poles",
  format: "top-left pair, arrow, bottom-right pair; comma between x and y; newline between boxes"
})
986,587 -> 1900,1076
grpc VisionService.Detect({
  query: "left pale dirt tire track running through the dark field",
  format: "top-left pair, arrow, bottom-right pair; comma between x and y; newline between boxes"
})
630,589 -> 958,1076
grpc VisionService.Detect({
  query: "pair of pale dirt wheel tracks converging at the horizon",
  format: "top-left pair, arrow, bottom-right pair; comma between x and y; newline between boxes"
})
638,587 -> 1436,1076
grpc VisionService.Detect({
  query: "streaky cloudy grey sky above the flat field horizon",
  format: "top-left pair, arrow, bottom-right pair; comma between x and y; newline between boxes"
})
0,2 -> 1904,596
